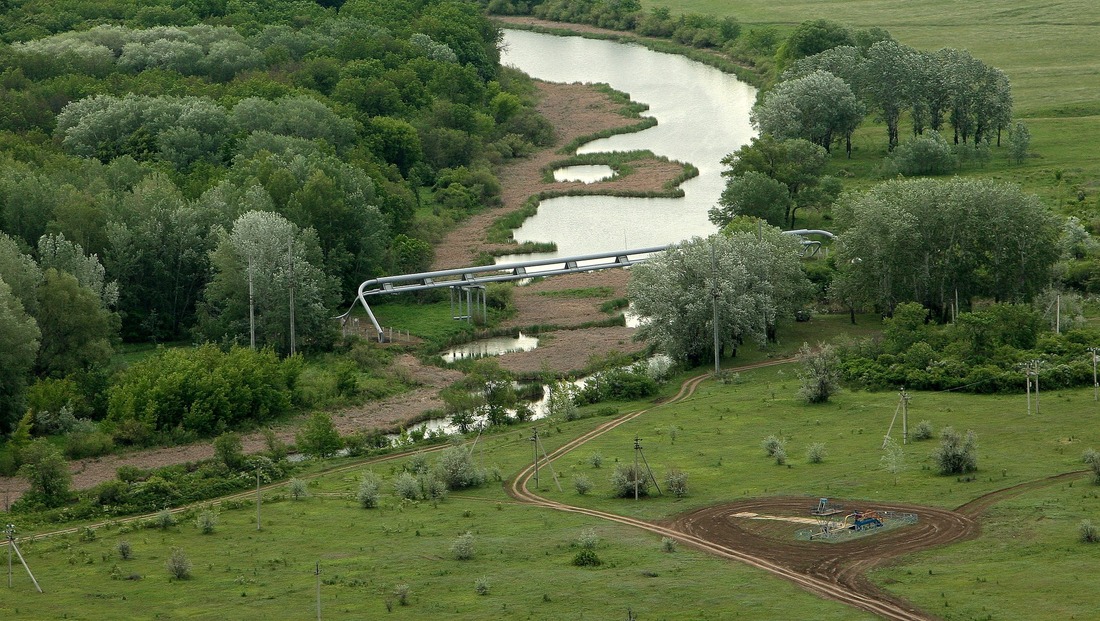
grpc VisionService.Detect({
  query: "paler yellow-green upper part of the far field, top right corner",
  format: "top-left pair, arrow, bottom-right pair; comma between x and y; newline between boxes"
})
642,0 -> 1100,112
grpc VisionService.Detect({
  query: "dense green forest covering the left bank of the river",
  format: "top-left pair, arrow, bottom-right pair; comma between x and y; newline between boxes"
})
0,0 -> 553,433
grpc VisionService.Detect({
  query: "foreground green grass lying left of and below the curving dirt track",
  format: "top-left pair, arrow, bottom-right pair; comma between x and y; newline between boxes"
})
0,402 -> 884,621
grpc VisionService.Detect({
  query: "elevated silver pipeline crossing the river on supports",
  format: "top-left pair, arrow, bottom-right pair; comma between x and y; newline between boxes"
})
339,229 -> 835,343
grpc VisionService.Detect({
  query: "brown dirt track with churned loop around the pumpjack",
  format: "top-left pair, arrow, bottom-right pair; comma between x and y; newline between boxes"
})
508,361 -> 1082,621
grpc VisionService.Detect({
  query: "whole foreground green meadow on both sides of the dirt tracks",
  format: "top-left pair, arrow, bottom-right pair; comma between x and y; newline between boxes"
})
8,349 -> 1100,620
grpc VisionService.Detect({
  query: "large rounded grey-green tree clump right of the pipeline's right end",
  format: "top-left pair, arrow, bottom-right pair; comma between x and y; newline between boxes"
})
833,179 -> 1062,318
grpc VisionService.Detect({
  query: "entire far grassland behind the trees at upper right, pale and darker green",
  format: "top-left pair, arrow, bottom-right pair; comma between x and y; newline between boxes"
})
642,0 -> 1100,211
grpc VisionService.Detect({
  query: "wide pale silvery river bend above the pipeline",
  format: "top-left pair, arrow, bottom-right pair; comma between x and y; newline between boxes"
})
498,30 -> 756,263
